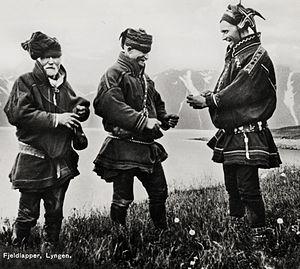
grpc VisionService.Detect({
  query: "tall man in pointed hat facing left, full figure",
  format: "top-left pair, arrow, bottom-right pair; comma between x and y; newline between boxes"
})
187,4 -> 281,241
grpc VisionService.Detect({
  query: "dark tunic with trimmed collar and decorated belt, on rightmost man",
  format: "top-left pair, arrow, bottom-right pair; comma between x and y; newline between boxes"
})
206,34 -> 281,168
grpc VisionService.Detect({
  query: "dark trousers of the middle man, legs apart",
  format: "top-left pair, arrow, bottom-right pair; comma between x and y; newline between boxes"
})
111,164 -> 168,228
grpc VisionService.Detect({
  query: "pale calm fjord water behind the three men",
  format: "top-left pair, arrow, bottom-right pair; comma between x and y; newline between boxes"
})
0,128 -> 300,219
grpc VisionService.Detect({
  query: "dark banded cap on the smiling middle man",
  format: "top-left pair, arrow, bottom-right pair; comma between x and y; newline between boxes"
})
120,28 -> 152,53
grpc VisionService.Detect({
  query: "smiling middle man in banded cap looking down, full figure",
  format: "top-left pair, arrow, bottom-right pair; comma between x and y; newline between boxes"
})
94,28 -> 178,229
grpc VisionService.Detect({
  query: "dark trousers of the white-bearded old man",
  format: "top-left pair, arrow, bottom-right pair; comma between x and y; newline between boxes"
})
14,181 -> 69,243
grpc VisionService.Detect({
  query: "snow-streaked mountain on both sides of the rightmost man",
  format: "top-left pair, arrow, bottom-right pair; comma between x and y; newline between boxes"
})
154,66 -> 300,129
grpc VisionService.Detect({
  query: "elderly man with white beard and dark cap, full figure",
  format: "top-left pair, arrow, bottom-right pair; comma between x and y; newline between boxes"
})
4,32 -> 90,251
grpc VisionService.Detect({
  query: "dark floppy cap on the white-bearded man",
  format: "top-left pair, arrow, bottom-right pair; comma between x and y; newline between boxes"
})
21,32 -> 61,60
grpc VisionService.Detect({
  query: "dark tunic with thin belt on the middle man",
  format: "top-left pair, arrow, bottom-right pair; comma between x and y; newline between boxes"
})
94,53 -> 167,181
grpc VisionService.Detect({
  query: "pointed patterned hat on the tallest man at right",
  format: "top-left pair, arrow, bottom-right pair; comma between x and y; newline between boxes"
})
220,4 -> 265,33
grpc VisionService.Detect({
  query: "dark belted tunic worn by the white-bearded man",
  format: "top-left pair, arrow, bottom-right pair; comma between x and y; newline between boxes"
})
4,61 -> 90,191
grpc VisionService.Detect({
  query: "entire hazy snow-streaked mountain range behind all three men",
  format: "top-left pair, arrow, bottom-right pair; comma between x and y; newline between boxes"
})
0,66 -> 300,129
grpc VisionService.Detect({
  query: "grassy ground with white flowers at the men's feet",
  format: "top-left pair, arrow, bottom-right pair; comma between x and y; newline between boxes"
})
0,164 -> 300,269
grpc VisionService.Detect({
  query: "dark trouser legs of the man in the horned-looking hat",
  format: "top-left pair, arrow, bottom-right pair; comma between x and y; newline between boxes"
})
223,165 -> 265,228
